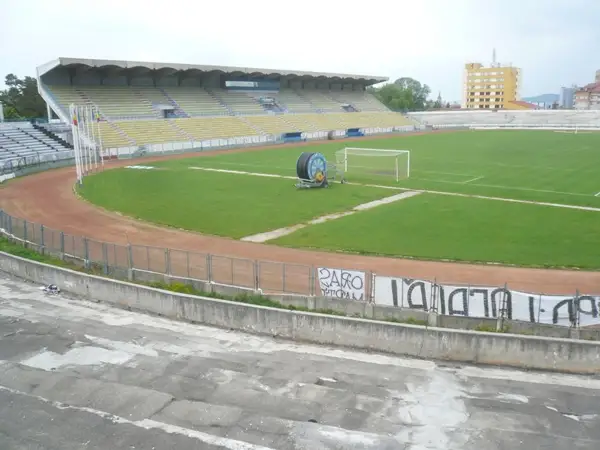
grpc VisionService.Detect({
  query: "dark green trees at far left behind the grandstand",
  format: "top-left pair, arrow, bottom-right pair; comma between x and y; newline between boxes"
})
0,73 -> 46,119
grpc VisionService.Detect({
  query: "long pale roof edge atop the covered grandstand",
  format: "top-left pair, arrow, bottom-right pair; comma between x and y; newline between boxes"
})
37,58 -> 389,85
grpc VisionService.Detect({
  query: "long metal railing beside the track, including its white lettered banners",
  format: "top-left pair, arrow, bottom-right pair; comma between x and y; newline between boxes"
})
0,210 -> 600,339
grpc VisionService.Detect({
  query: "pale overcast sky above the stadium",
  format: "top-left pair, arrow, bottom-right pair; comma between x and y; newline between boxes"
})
0,0 -> 600,100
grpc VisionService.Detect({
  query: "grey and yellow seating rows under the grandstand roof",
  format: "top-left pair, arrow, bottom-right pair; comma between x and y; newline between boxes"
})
48,81 -> 422,148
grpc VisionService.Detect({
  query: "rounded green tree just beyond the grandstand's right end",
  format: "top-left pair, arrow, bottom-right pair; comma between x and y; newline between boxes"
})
369,77 -> 431,111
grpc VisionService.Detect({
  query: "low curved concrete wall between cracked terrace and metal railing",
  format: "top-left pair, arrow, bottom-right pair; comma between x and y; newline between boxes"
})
0,252 -> 600,374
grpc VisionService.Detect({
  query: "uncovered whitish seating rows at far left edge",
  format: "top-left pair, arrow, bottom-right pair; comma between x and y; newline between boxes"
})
0,123 -> 73,163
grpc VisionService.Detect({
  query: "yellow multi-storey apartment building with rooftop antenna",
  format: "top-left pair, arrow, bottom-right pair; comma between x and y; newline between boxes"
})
461,63 -> 521,109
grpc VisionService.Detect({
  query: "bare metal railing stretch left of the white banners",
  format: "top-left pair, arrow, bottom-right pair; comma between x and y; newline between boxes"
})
0,211 -> 328,296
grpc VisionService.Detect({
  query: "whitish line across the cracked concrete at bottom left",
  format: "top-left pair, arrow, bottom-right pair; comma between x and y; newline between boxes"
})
0,386 -> 274,450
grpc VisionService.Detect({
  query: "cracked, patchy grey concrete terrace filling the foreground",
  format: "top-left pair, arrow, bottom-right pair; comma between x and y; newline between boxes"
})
0,275 -> 600,450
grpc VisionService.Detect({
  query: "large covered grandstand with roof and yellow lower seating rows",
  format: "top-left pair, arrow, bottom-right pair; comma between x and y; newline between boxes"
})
37,58 -> 415,155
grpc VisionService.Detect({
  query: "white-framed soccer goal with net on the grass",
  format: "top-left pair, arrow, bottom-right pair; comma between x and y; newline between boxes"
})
335,147 -> 410,181
